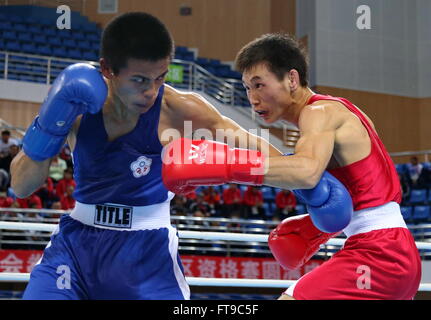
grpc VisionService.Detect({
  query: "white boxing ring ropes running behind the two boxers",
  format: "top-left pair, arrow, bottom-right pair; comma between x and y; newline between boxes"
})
0,221 -> 431,291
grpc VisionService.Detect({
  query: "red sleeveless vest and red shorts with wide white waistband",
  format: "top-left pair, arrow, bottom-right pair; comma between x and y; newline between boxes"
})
286,94 -> 421,300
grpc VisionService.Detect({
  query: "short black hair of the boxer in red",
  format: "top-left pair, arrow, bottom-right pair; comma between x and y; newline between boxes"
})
235,33 -> 308,87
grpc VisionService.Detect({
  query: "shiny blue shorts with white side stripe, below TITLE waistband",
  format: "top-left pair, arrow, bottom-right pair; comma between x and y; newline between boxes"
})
23,204 -> 190,300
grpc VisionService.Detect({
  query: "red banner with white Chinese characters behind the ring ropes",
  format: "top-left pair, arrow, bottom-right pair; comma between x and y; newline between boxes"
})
0,250 -> 323,280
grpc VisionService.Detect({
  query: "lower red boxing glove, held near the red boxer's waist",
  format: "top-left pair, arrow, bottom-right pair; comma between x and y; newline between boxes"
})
268,214 -> 341,270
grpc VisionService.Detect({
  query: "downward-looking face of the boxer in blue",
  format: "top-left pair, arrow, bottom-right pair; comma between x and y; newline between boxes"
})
105,57 -> 170,113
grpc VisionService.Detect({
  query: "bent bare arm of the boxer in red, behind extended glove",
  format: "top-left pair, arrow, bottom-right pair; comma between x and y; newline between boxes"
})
264,105 -> 341,190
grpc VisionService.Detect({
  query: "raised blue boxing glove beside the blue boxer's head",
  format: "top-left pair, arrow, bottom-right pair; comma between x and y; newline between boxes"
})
23,63 -> 108,161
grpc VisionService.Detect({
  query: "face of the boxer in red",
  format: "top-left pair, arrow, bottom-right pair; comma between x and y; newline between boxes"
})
242,63 -> 292,123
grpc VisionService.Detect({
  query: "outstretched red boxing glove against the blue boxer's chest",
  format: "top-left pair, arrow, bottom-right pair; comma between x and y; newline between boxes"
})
162,138 -> 264,193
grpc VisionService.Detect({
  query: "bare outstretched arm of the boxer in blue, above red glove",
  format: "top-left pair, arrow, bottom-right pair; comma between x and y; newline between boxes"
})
167,87 -> 282,156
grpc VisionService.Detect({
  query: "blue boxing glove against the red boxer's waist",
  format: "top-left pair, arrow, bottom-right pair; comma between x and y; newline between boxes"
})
293,171 -> 353,233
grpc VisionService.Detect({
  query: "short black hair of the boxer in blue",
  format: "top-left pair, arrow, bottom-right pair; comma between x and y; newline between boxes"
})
100,12 -> 175,74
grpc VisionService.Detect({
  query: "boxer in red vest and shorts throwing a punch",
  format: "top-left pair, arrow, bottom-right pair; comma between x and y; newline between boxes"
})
162,34 -> 421,299
